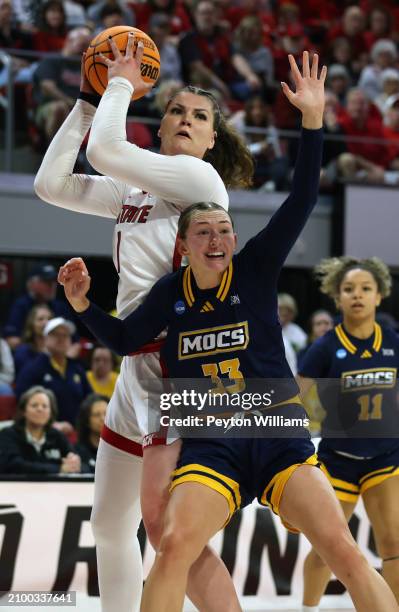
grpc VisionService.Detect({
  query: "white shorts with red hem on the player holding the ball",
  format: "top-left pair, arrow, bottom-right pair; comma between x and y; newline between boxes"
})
101,352 -> 176,456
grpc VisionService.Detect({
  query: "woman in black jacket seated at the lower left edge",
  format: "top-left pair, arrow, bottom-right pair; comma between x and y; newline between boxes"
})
0,386 -> 81,474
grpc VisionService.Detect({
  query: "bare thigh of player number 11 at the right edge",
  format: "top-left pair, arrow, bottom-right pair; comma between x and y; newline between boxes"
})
363,475 -> 399,558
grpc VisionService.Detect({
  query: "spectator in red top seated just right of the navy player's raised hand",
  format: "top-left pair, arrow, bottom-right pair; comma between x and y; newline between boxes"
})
340,88 -> 389,169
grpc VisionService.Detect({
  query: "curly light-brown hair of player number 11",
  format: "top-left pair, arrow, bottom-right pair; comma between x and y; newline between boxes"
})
315,257 -> 392,300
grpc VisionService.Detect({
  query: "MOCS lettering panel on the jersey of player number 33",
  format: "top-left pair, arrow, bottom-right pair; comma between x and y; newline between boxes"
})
179,321 -> 249,359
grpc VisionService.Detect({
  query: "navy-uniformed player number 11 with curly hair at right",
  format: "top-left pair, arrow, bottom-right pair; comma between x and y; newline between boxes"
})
299,257 -> 399,612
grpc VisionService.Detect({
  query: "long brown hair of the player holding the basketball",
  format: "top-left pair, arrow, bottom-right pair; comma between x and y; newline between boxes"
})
165,85 -> 254,189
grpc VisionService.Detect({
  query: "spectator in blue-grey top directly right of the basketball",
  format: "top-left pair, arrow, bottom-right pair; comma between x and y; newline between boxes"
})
147,13 -> 182,83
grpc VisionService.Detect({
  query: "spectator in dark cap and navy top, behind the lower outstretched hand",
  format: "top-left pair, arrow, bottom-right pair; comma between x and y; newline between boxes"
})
3,264 -> 74,349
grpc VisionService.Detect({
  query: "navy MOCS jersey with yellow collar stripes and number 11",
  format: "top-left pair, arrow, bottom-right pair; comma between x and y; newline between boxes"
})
300,323 -> 399,457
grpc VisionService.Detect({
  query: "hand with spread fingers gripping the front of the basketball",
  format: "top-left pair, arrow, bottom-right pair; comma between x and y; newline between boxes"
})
100,32 -> 153,97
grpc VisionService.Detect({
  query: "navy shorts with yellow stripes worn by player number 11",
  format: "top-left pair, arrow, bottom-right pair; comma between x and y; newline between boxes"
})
318,446 -> 399,504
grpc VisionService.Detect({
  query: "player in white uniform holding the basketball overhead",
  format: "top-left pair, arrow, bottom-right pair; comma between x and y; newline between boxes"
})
35,38 -> 253,612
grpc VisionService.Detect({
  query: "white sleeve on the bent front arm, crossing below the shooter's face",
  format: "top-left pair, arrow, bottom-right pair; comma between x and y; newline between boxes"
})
87,77 -> 228,209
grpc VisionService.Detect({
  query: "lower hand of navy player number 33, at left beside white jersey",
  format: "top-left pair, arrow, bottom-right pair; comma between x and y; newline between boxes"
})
58,257 -> 91,312
